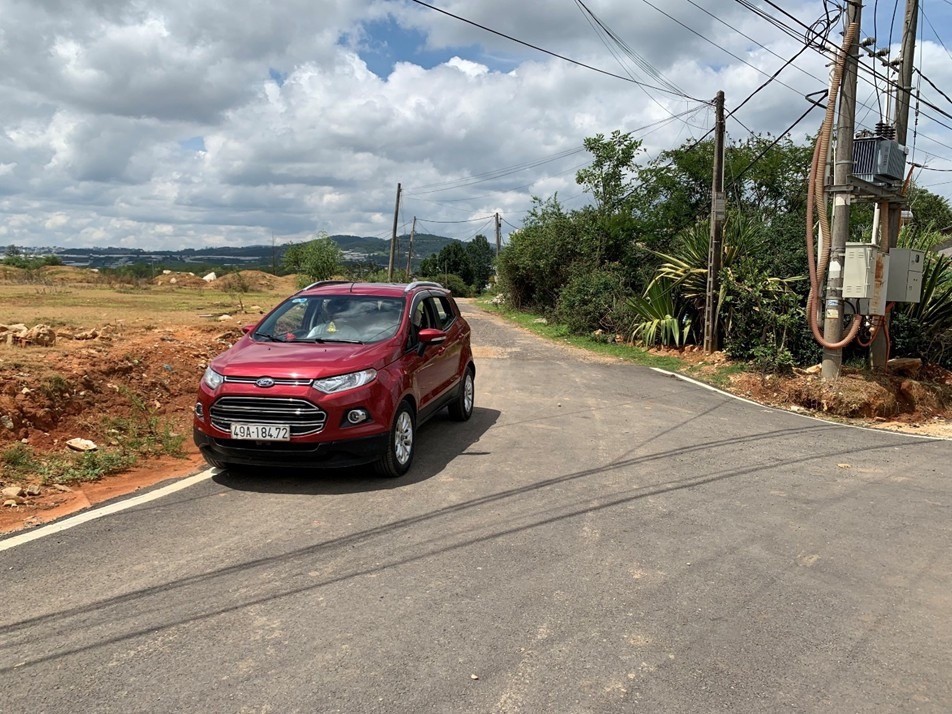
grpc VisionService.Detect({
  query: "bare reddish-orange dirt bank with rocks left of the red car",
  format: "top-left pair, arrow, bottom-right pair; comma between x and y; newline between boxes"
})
0,324 -> 240,533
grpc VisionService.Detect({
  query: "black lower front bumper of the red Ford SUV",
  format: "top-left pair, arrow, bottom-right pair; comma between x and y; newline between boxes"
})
192,427 -> 389,468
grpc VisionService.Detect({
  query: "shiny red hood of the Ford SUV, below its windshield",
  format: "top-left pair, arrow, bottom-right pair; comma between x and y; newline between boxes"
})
211,336 -> 399,379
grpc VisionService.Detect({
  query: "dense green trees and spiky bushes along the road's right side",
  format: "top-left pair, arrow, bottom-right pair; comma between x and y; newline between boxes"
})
497,132 -> 952,373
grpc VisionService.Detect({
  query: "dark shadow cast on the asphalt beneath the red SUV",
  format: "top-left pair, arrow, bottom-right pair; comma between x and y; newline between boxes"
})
212,407 -> 500,496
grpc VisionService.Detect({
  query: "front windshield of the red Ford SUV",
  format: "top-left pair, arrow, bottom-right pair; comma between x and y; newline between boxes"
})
253,294 -> 404,343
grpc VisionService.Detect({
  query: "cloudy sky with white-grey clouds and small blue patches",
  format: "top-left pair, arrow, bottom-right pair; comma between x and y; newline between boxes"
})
0,0 -> 952,250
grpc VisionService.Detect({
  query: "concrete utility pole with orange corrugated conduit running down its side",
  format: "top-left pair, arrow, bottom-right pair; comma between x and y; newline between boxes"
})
820,2 -> 863,379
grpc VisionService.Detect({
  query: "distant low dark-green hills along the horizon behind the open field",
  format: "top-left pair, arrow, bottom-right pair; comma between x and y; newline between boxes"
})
20,233 -> 459,270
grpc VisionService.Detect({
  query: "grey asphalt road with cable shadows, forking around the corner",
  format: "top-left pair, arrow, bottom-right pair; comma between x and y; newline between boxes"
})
0,308 -> 952,713
